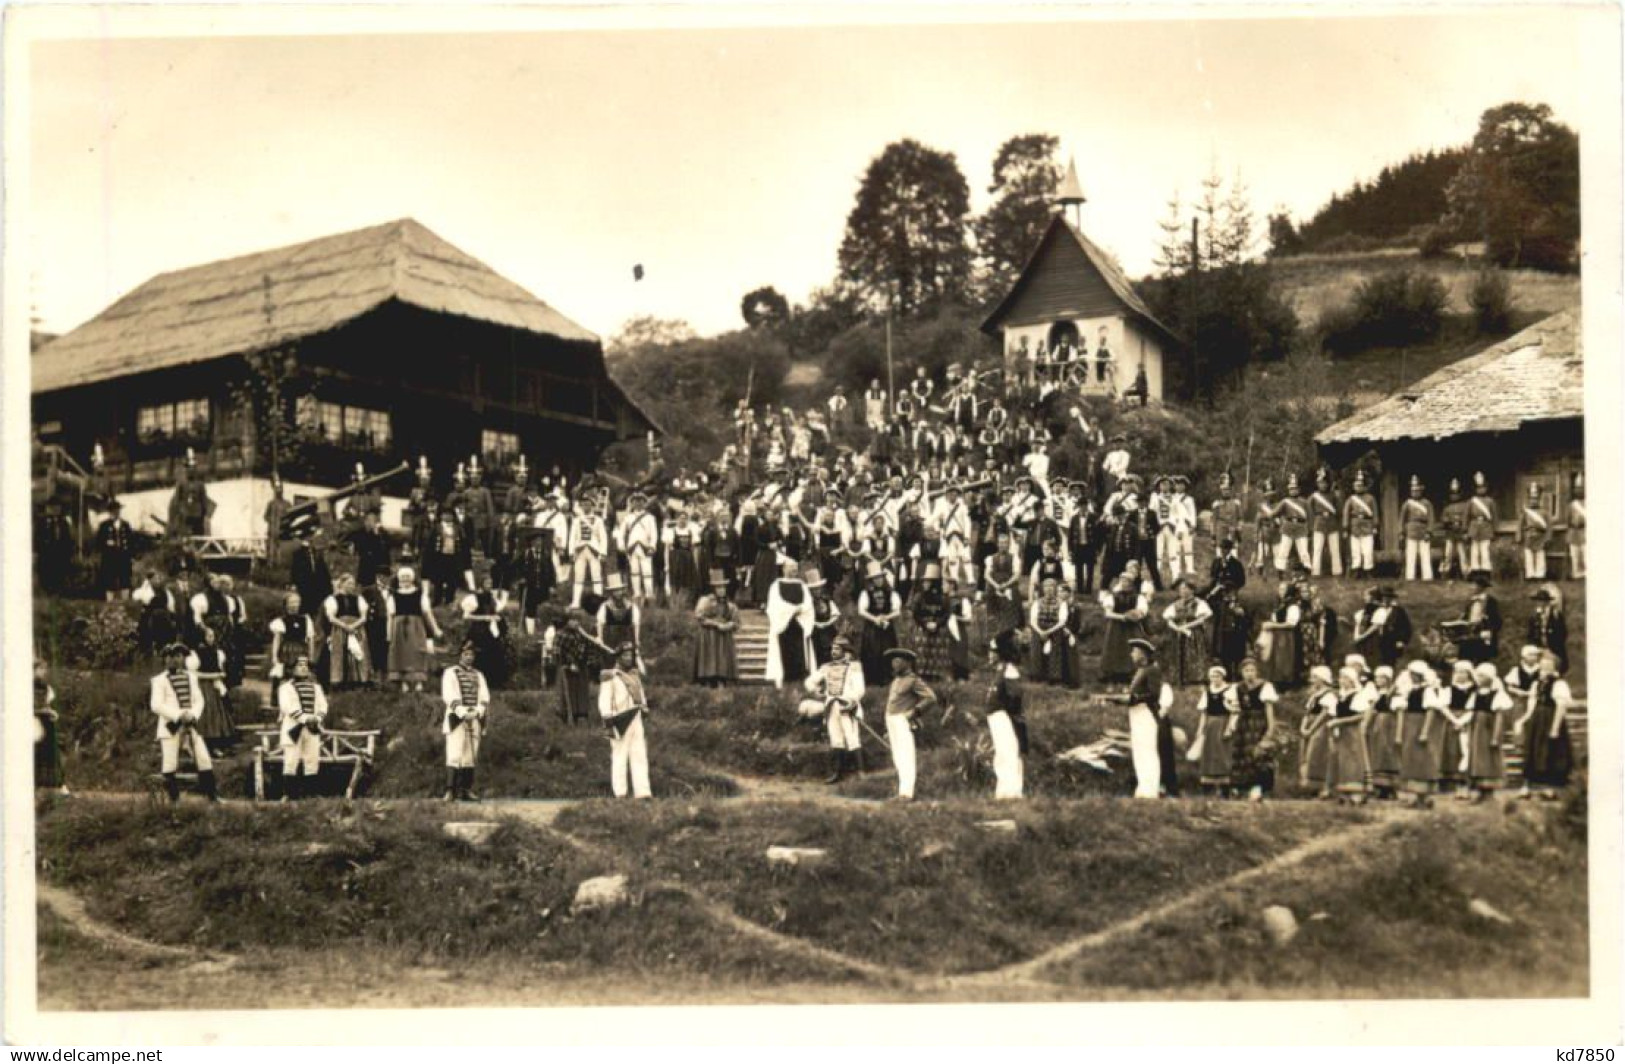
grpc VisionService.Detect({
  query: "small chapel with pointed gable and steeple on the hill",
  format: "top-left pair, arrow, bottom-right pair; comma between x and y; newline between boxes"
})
982,167 -> 1180,401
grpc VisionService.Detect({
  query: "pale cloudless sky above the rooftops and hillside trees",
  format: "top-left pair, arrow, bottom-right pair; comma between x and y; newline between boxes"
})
29,10 -> 1592,338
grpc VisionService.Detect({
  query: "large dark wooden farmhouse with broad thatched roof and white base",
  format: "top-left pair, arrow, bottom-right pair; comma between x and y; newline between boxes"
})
33,219 -> 655,538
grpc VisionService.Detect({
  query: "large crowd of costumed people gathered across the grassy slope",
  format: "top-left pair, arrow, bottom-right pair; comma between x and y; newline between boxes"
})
34,343 -> 1584,799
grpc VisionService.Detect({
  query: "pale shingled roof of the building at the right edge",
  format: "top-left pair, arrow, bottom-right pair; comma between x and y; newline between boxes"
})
1315,310 -> 1584,445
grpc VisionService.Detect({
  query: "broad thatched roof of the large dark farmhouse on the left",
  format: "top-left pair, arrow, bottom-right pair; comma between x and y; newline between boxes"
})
33,218 -> 598,393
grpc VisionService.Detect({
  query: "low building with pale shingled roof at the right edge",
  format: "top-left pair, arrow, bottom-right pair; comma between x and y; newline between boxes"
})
1316,312 -> 1586,547
